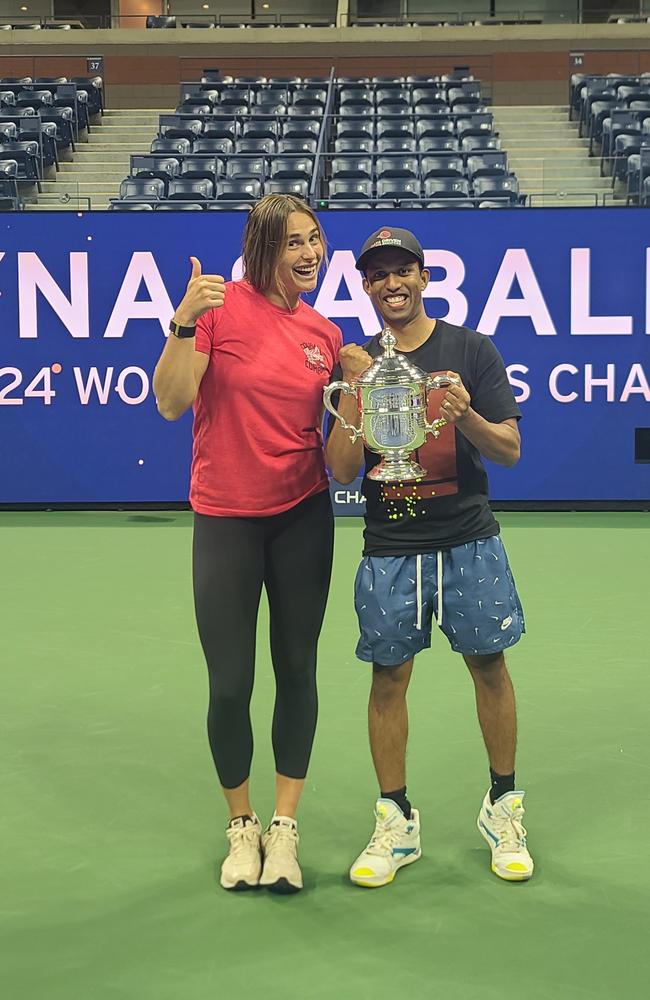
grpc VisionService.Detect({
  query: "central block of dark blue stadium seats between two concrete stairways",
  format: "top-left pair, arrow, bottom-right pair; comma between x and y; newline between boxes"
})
114,73 -> 521,207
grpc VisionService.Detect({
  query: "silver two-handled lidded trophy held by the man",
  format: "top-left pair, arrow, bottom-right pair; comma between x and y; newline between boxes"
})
323,328 -> 460,483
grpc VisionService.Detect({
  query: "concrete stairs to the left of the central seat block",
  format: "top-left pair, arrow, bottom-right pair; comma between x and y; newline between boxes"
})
27,108 -> 172,212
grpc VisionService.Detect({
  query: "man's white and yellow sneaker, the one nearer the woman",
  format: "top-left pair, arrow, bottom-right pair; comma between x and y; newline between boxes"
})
350,799 -> 422,889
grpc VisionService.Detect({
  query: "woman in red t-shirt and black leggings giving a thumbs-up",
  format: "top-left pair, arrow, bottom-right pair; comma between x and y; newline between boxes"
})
153,195 -> 342,892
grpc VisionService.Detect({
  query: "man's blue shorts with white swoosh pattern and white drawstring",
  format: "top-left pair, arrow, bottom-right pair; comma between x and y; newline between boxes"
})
354,535 -> 526,667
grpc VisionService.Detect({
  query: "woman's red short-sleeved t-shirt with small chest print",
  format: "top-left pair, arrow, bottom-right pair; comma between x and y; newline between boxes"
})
190,281 -> 342,517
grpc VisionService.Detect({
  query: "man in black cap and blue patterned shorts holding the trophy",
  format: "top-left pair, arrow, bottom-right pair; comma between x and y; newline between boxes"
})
326,227 -> 533,887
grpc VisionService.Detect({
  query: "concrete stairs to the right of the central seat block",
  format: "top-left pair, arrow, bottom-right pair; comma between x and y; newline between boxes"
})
492,105 -> 623,208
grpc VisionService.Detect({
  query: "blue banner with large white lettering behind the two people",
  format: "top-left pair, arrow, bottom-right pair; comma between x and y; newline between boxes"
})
0,209 -> 650,512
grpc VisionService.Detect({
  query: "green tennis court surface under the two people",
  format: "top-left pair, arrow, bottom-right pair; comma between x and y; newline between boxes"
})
0,513 -> 650,1000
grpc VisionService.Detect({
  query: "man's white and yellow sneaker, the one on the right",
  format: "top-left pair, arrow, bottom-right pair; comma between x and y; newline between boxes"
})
477,792 -> 535,882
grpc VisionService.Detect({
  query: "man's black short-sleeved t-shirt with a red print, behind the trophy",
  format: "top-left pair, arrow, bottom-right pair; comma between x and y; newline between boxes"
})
332,320 -> 521,556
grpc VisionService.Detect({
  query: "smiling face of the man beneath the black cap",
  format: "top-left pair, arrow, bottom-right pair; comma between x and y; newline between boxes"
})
363,248 -> 429,326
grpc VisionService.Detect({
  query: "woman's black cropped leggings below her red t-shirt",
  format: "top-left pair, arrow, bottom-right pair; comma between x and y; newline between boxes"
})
193,490 -> 334,788
